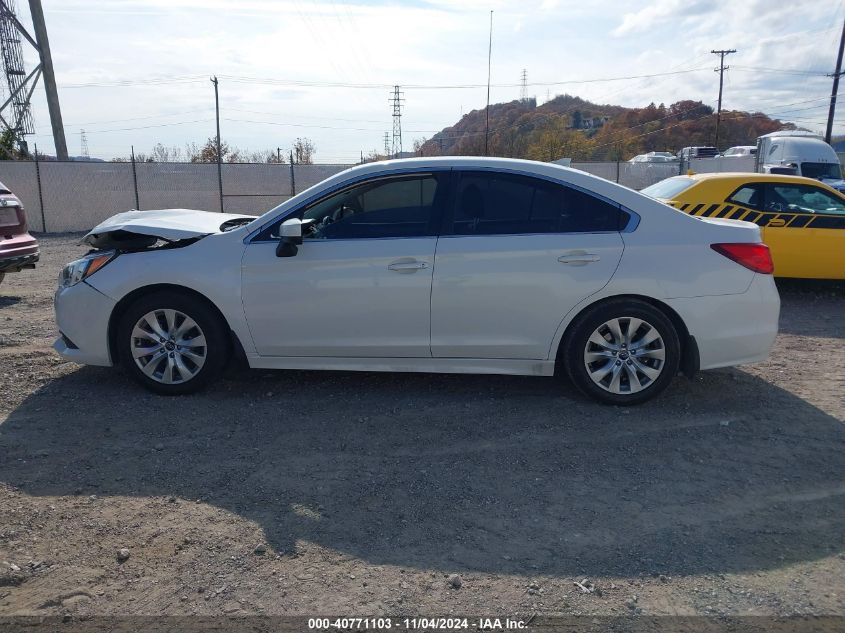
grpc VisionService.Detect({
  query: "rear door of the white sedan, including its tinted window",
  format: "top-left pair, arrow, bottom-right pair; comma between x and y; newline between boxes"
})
431,171 -> 628,359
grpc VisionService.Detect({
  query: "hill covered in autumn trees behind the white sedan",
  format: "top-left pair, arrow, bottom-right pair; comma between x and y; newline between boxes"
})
422,95 -> 795,160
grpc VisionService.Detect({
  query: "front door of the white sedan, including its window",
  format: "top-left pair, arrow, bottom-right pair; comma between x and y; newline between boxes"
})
242,172 -> 448,358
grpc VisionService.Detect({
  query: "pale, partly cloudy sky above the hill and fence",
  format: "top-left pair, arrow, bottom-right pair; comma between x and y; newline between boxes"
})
6,0 -> 845,163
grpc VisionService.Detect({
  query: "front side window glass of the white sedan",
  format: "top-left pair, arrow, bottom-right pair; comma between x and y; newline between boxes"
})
259,174 -> 447,240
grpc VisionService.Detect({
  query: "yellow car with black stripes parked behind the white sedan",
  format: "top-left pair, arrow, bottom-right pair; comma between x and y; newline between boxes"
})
642,173 -> 845,279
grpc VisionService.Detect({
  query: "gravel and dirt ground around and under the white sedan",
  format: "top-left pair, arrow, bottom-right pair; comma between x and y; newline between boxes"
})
0,236 -> 845,616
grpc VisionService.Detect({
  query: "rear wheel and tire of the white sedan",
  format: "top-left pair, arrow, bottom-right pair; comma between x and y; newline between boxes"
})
560,299 -> 681,406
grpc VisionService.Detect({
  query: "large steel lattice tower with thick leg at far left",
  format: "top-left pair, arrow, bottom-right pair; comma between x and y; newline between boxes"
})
0,0 -> 68,160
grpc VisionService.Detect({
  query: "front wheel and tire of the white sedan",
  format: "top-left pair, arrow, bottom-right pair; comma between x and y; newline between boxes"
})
115,290 -> 231,396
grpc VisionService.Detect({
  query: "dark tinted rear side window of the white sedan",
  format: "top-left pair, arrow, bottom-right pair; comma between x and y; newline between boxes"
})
445,172 -> 628,235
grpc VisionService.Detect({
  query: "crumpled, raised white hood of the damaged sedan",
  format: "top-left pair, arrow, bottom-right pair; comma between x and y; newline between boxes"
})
81,209 -> 255,246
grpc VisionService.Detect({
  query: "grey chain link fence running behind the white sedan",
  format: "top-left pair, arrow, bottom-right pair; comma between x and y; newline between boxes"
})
0,161 -> 679,233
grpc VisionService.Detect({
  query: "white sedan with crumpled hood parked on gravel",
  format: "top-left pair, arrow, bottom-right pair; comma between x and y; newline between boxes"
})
55,158 -> 780,405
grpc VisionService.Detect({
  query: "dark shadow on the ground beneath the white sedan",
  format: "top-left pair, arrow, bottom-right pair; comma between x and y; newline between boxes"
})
0,368 -> 845,576
